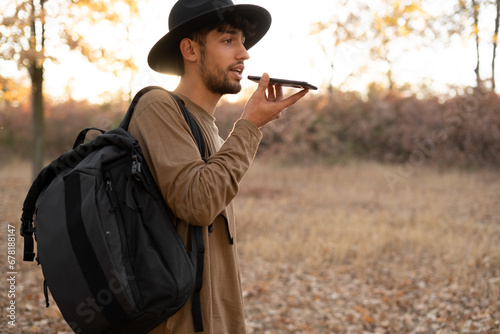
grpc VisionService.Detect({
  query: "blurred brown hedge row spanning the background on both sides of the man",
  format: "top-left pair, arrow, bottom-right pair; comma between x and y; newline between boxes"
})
0,88 -> 500,167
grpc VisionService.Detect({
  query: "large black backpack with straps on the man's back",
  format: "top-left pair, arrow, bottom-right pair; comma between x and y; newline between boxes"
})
21,87 -> 205,334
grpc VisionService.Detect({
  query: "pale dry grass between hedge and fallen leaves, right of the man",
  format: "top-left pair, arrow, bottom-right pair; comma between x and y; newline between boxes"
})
237,159 -> 500,301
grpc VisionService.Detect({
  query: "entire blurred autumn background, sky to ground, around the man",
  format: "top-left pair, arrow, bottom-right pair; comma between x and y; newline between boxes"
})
0,0 -> 500,334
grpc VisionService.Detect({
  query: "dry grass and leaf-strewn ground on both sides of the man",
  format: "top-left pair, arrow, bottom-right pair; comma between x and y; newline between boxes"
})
0,161 -> 500,334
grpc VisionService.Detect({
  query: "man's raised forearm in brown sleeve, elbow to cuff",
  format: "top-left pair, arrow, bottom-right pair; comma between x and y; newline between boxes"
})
165,120 -> 261,225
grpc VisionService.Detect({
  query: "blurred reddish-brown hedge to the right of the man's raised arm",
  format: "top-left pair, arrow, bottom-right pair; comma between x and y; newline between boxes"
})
222,88 -> 500,167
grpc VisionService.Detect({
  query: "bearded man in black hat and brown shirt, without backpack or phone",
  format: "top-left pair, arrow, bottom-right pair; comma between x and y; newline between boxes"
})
129,0 -> 307,334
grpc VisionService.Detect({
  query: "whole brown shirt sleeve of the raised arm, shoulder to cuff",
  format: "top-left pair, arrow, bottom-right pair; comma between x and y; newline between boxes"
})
129,91 -> 262,226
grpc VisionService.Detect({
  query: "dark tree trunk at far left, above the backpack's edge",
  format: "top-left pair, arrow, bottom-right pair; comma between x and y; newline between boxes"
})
29,63 -> 45,178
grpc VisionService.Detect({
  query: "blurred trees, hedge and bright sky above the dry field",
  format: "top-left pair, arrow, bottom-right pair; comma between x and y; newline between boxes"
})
0,0 -> 500,176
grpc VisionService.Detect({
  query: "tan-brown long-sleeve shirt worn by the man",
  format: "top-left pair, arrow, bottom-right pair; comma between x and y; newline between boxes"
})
129,90 -> 262,334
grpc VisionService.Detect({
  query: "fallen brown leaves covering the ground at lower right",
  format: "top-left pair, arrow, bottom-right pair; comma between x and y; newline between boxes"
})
242,259 -> 500,334
